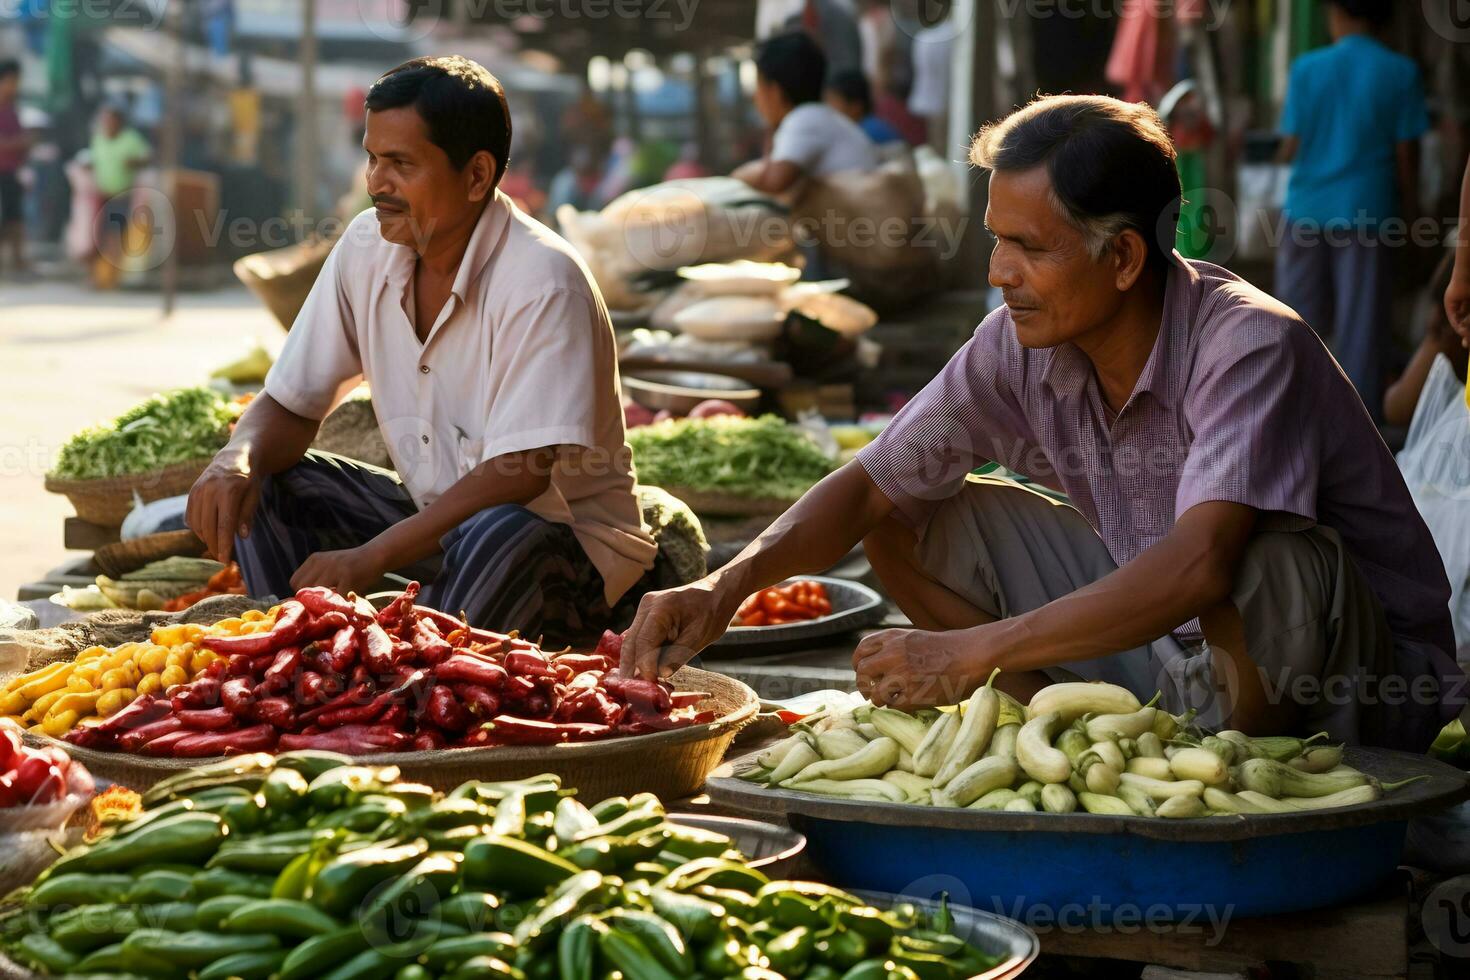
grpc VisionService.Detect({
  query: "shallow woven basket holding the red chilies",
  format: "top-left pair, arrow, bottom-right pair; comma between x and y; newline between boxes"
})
34,667 -> 759,802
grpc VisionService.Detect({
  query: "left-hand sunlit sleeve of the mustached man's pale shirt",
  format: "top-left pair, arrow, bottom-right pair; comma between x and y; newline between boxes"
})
265,237 -> 363,420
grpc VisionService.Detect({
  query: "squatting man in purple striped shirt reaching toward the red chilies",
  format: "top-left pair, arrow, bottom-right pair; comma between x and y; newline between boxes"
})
623,96 -> 1464,751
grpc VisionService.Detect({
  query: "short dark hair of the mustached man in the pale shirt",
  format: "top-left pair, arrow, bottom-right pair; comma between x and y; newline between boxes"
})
363,54 -> 510,185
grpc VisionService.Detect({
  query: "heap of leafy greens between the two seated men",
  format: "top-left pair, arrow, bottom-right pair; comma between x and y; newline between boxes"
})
628,416 -> 833,500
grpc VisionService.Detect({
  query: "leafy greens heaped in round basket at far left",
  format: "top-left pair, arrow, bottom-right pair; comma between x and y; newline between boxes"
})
51,388 -> 241,480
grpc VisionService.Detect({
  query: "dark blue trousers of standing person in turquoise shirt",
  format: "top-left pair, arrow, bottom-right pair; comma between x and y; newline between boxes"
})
1276,229 -> 1394,419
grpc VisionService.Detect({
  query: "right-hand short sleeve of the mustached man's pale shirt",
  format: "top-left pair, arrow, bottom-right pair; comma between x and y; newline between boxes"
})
481,289 -> 599,463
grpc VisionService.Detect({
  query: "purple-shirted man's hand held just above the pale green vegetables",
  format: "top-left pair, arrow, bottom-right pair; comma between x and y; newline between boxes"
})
853,627 -> 991,710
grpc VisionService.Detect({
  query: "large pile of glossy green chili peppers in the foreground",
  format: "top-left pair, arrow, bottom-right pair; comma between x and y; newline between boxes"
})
0,752 -> 997,980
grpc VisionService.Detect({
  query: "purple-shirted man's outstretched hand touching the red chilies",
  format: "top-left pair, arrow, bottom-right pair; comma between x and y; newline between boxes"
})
622,579 -> 744,680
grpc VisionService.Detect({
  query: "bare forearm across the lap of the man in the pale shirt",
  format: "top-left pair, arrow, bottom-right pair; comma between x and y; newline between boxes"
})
368,450 -> 556,572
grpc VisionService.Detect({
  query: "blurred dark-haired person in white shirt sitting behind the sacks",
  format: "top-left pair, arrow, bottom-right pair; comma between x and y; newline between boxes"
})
732,32 -> 878,194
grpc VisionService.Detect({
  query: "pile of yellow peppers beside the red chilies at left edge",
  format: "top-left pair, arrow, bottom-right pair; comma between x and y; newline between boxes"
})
0,620 -> 238,738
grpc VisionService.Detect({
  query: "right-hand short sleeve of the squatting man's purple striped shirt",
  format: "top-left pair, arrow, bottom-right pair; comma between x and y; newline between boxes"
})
1175,318 -> 1333,529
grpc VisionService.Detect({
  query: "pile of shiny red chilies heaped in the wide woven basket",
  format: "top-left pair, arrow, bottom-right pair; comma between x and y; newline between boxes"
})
66,583 -> 714,757
